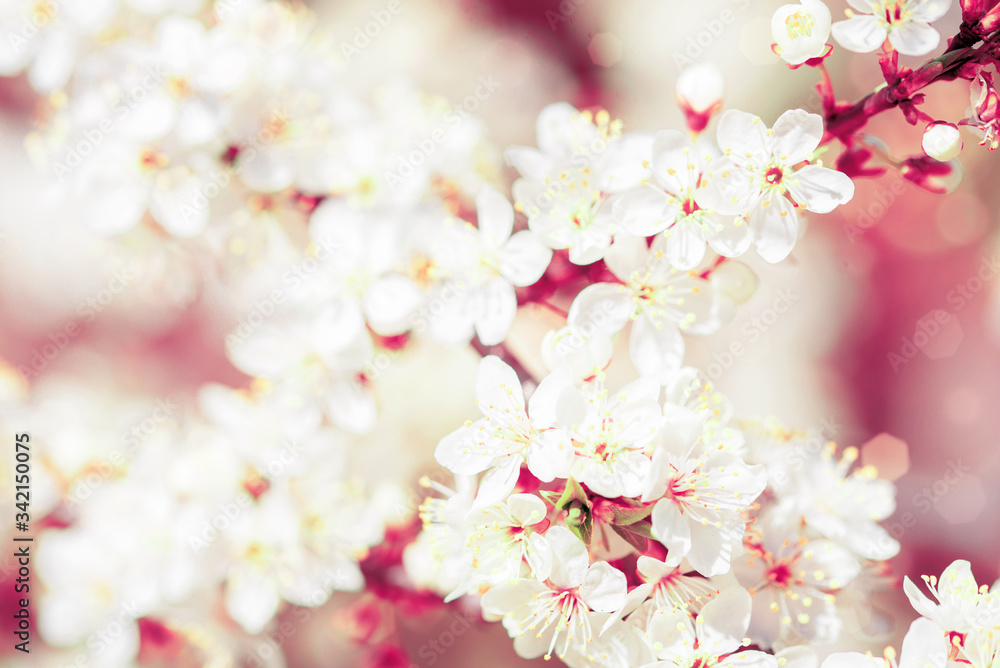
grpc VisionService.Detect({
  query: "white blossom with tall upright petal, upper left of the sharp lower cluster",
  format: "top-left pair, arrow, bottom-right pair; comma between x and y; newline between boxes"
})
434,355 -> 573,509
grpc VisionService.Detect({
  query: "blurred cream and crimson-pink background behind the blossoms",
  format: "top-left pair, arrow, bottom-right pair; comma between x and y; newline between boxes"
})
0,0 -> 1000,667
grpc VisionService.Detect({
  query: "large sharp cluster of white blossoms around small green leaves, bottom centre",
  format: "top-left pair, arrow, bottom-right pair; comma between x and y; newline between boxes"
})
405,366 -> 912,666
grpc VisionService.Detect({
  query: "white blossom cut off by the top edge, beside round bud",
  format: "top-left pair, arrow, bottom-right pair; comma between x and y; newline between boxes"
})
833,0 -> 951,56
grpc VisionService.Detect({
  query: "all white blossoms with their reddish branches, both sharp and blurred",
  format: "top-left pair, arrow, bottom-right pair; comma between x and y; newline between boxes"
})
0,0 -> 1000,668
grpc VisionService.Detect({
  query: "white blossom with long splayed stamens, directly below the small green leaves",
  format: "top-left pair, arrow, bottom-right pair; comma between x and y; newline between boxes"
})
482,526 -> 626,659
